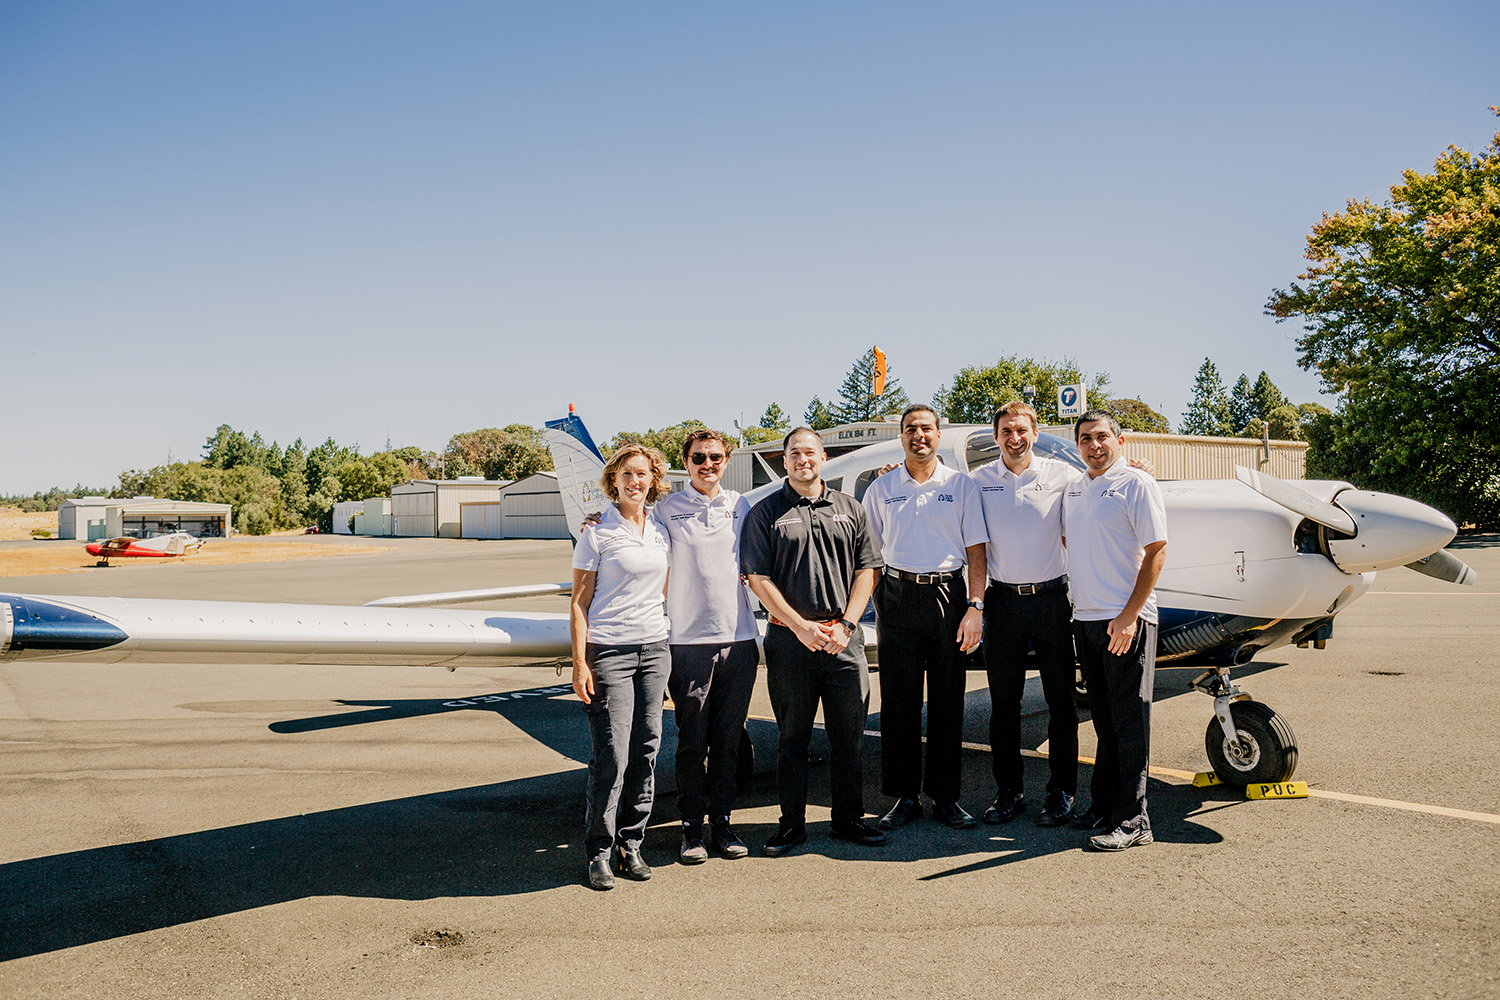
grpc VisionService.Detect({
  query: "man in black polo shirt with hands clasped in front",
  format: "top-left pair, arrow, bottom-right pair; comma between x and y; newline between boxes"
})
740,427 -> 885,858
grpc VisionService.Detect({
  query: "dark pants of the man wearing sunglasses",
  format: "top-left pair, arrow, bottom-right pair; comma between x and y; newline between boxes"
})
666,639 -> 761,823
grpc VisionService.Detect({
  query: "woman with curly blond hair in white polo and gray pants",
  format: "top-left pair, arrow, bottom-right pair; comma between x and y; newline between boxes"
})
572,444 -> 672,889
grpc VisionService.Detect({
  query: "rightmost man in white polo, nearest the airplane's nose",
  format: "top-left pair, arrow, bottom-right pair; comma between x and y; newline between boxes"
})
1062,409 -> 1167,850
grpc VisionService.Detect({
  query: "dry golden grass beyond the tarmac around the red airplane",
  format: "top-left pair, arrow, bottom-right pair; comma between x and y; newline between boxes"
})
0,507 -> 389,577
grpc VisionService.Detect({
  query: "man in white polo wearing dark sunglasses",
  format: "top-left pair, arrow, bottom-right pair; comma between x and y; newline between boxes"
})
651,429 -> 761,865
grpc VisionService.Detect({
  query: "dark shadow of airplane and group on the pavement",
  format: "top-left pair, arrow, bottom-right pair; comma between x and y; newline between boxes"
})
0,664 -> 1277,961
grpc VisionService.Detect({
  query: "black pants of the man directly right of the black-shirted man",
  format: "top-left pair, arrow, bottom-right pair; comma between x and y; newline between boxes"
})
875,574 -> 969,802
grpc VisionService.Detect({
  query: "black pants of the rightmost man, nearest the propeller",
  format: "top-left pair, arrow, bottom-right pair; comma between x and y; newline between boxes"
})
1073,618 -> 1157,831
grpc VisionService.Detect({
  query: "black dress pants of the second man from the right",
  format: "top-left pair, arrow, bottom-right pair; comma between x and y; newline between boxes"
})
984,583 -> 1079,795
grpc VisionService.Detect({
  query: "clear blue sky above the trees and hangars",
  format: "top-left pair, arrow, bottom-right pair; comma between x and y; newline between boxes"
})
0,0 -> 1500,493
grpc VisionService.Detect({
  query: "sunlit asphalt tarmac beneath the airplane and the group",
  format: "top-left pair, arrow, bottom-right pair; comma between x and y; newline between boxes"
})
0,535 -> 1500,999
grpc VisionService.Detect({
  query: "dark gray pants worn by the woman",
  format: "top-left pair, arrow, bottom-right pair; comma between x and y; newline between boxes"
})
584,642 -> 672,861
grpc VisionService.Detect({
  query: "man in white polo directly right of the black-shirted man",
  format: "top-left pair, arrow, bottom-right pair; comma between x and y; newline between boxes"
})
864,405 -> 987,829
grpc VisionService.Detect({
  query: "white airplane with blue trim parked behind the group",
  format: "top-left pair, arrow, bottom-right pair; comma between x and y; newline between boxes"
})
0,406 -> 1476,786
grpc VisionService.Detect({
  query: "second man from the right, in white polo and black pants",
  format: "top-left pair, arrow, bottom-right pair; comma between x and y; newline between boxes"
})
969,400 -> 1082,826
